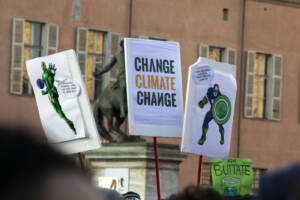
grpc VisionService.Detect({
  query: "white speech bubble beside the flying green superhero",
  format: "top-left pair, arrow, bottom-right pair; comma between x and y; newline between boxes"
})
56,79 -> 81,98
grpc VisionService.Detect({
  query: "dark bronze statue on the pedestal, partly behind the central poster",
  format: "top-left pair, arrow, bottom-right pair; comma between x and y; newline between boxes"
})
93,39 -> 140,142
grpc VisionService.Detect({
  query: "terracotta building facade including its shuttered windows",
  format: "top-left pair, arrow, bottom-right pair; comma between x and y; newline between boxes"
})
0,0 -> 300,192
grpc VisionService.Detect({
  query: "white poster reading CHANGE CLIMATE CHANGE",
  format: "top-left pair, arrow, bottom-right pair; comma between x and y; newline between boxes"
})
125,38 -> 183,137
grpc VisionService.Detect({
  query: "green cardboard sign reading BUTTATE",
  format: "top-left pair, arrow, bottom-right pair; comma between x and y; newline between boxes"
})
211,158 -> 253,196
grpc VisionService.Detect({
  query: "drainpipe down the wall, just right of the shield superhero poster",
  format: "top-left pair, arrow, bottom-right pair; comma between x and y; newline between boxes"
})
237,0 -> 246,158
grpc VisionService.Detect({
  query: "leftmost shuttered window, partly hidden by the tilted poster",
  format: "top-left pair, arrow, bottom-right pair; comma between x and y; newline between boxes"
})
10,18 -> 58,95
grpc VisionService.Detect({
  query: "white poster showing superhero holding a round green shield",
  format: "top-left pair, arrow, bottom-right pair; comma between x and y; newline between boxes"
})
181,58 -> 237,159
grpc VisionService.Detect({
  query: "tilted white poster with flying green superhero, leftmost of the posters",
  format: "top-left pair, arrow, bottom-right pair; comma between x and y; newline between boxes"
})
26,50 -> 100,153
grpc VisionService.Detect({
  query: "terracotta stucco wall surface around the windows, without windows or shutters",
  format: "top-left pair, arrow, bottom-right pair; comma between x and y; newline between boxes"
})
0,0 -> 300,191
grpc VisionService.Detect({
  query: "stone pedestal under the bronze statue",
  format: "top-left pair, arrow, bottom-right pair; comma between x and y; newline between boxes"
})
85,142 -> 186,200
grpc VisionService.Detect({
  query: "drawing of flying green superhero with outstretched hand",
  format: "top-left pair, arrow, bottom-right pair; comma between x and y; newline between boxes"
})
37,62 -> 77,135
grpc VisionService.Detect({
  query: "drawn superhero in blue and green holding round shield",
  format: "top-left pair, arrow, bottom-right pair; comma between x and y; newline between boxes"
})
198,84 -> 231,145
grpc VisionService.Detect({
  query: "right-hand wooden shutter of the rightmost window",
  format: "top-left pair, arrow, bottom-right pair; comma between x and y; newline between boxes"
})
266,55 -> 282,121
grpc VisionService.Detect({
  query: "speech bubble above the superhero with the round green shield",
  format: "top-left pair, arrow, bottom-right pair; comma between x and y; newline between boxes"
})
192,66 -> 215,85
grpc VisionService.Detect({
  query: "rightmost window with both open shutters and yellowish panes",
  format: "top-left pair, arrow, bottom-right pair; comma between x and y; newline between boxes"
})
244,51 -> 282,120
